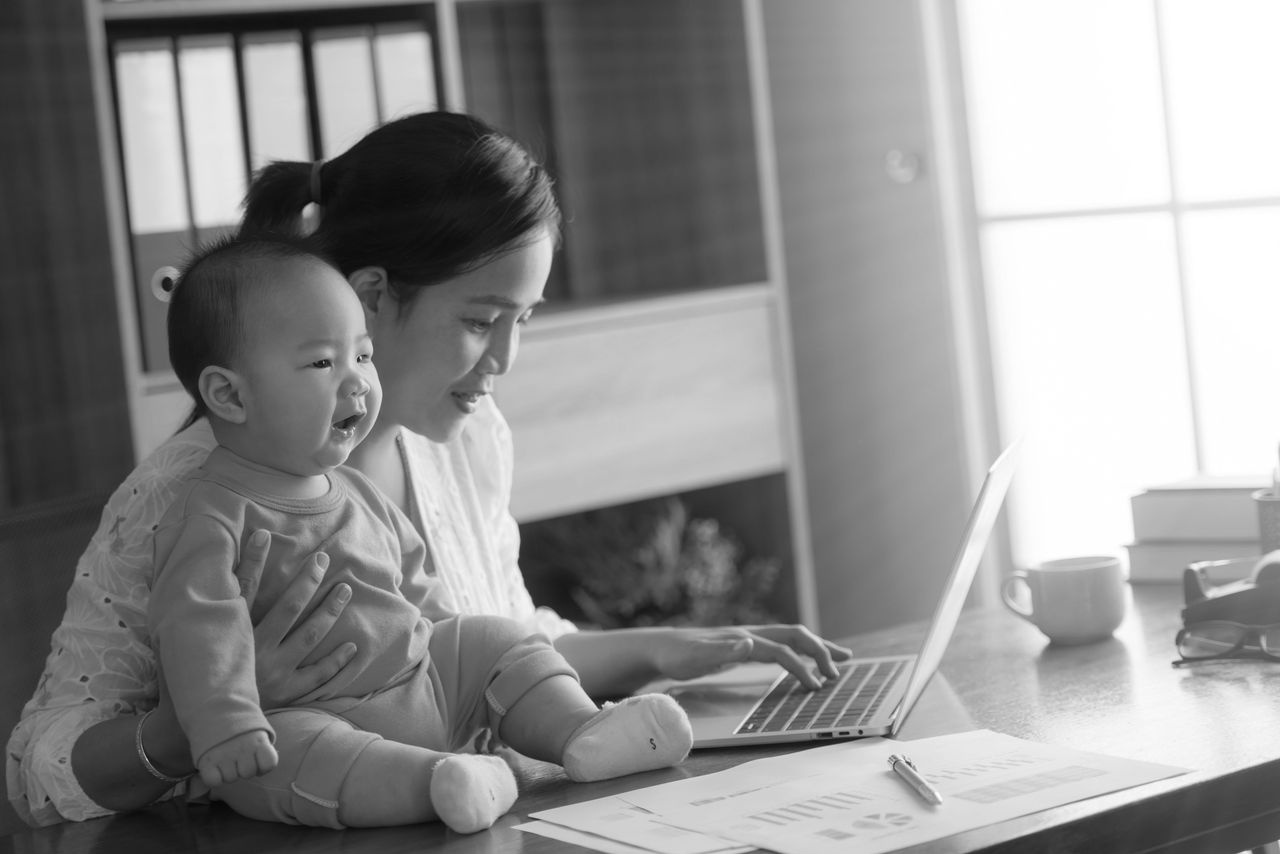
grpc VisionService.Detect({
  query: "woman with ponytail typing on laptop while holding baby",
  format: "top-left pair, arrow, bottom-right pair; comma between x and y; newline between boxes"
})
6,113 -> 849,823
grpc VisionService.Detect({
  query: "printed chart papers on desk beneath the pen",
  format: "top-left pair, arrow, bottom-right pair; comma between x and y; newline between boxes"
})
520,730 -> 1187,854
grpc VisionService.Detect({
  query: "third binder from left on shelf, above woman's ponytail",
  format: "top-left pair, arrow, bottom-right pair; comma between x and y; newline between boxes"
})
241,31 -> 315,172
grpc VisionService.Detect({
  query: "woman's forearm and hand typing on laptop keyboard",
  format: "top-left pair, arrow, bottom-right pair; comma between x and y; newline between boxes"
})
554,625 -> 852,698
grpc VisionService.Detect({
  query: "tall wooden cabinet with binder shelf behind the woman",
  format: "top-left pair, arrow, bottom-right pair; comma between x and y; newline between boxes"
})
86,0 -> 817,625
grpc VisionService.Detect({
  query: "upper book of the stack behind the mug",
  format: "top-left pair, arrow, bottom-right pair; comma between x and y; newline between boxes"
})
1129,475 -> 1270,542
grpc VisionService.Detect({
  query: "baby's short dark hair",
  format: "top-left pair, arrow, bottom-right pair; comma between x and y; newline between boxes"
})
168,232 -> 333,421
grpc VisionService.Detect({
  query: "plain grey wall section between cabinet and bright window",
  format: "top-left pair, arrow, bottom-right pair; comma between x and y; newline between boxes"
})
763,0 -> 973,636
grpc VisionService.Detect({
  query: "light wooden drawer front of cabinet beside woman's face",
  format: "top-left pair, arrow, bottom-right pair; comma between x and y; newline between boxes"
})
495,286 -> 786,520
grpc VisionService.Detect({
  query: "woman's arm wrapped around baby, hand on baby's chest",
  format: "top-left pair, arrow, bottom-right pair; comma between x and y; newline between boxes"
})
72,531 -> 356,812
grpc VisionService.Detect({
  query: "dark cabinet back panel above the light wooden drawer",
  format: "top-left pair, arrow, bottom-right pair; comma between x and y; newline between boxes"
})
545,0 -> 765,297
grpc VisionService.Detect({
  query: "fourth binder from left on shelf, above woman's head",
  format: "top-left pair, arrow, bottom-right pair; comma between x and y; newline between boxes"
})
311,27 -> 378,157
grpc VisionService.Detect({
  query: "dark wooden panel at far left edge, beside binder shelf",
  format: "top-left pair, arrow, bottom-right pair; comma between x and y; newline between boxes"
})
0,0 -> 132,508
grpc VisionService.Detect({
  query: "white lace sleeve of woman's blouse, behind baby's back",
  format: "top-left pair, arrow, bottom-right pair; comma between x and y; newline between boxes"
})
5,423 -> 212,825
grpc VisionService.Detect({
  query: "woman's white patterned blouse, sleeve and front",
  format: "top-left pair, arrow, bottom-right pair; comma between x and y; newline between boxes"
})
5,398 -> 575,825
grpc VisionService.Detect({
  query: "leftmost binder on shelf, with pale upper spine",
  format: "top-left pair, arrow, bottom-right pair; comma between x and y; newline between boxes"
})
111,38 -> 193,373
